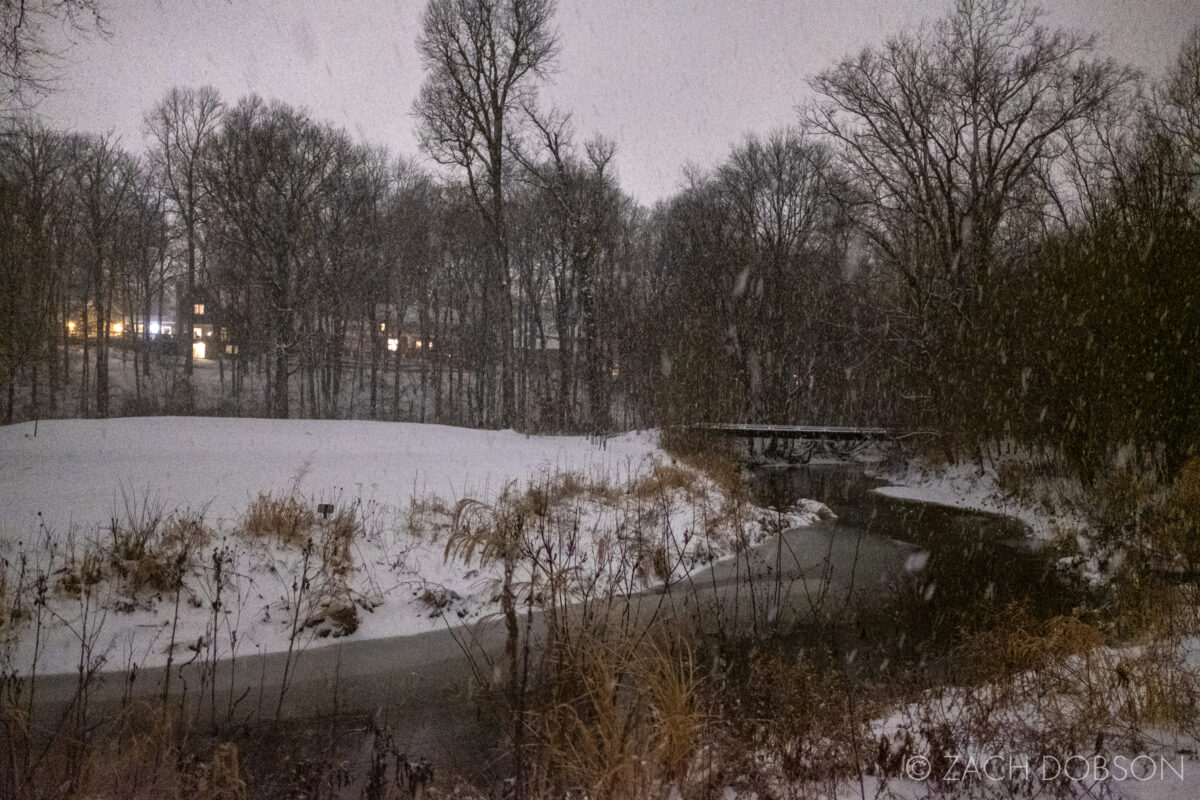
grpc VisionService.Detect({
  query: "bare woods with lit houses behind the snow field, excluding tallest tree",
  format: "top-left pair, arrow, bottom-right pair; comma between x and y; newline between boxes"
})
0,89 -> 635,429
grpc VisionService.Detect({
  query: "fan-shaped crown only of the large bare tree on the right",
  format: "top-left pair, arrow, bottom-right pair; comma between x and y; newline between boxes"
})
806,0 -> 1133,319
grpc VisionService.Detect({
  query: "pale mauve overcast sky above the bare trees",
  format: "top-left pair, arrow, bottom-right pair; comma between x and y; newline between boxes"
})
40,0 -> 1200,203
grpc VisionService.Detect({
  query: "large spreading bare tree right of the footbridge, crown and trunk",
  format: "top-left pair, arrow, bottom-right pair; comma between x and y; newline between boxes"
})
805,0 -> 1134,422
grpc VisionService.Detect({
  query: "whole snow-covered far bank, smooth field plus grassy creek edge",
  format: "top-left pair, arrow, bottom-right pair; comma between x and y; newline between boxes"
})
0,417 -> 828,673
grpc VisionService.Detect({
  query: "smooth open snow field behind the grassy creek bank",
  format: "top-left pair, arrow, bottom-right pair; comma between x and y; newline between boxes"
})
0,416 -> 659,542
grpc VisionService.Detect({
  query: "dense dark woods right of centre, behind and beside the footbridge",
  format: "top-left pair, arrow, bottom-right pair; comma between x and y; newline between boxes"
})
644,0 -> 1200,473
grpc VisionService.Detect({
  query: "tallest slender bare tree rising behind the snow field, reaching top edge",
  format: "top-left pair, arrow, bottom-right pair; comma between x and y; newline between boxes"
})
415,0 -> 557,423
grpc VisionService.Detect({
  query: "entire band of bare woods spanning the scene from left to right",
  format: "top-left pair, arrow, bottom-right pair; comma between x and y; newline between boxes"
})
0,0 -> 1200,470
